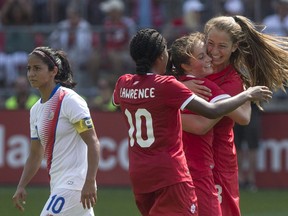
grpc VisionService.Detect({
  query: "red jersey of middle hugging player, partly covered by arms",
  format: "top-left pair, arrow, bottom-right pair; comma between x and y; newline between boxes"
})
179,75 -> 230,179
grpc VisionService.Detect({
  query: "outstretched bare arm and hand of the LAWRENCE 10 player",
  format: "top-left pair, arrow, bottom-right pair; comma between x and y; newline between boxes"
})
186,86 -> 272,119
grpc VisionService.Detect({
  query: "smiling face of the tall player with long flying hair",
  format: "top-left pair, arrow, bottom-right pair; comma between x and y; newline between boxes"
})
207,28 -> 237,72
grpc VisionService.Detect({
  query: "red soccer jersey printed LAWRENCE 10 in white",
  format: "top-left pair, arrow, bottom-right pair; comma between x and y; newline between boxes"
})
113,73 -> 195,193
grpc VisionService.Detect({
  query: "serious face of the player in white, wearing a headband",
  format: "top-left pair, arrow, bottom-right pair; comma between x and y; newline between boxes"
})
27,54 -> 57,91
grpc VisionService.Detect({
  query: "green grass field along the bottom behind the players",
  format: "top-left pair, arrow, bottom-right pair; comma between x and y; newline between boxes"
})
0,186 -> 288,216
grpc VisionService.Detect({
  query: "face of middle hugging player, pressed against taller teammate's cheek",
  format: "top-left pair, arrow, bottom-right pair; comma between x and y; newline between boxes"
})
181,41 -> 213,78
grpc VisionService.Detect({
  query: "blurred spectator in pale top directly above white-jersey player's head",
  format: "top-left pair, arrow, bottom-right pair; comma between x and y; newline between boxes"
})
49,1 -> 93,89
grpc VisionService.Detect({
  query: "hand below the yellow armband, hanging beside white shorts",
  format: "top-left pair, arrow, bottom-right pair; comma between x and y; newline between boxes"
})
81,180 -> 97,209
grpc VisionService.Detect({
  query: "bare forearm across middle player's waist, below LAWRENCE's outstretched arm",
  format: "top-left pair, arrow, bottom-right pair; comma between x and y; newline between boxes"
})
181,114 -> 221,135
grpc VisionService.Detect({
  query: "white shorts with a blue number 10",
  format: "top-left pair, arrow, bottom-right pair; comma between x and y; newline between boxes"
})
40,188 -> 94,216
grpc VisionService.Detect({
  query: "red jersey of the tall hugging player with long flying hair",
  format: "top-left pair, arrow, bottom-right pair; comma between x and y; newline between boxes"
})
207,65 -> 244,172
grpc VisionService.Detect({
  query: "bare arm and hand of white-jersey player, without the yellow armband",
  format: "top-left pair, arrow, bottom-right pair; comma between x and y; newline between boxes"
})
12,140 -> 44,211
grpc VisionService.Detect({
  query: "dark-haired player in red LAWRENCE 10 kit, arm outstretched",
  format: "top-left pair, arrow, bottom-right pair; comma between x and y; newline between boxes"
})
113,28 -> 271,216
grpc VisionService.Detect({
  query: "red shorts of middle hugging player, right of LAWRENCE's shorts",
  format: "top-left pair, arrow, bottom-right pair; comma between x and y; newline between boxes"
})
193,175 -> 222,216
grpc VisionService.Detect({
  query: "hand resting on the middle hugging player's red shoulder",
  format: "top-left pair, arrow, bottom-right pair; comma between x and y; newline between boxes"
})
183,79 -> 212,101
